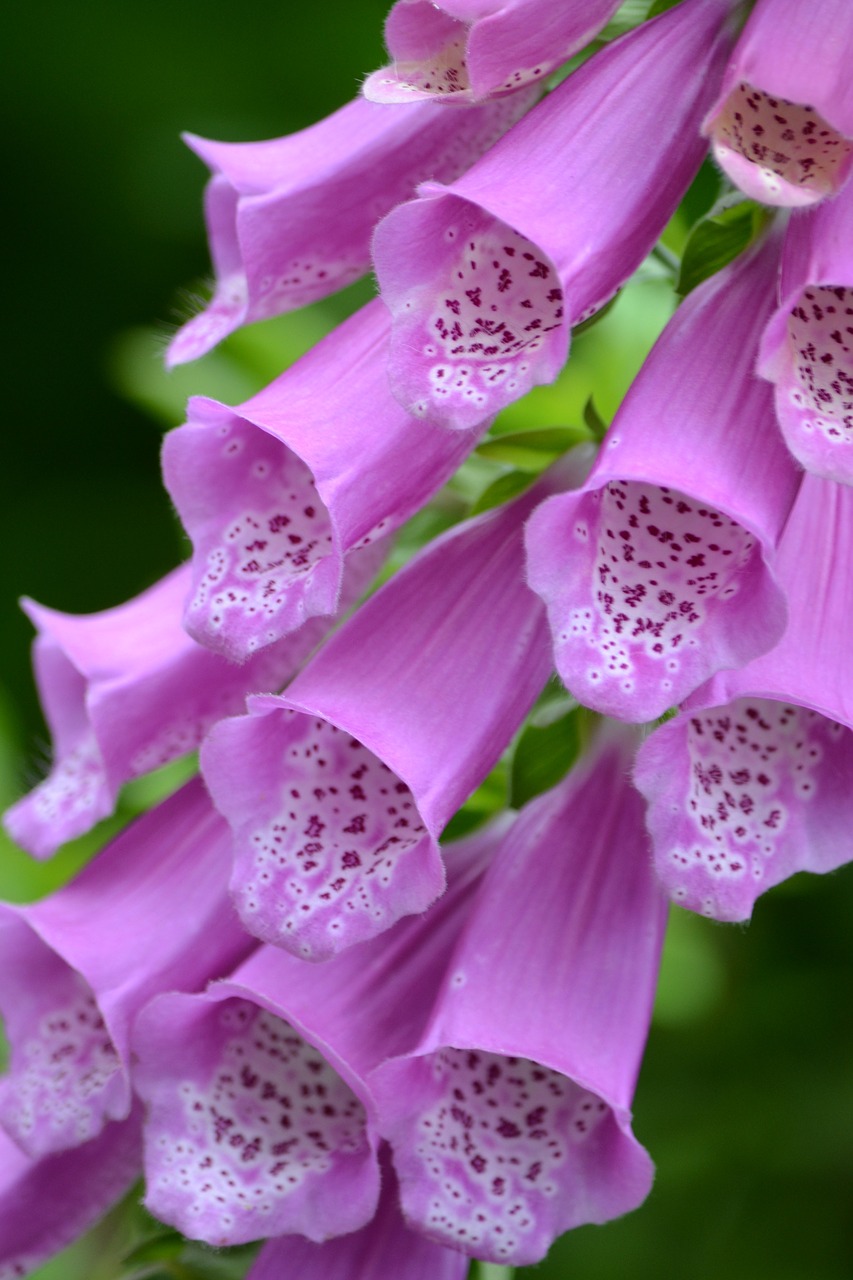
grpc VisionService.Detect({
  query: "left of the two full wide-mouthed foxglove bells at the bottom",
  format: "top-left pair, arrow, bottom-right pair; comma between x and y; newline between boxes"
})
133,820 -> 507,1244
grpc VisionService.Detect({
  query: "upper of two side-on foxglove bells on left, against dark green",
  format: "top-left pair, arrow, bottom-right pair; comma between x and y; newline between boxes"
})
167,93 -> 532,365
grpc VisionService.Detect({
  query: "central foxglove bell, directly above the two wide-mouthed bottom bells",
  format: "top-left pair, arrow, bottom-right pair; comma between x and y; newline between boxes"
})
201,451 -> 578,960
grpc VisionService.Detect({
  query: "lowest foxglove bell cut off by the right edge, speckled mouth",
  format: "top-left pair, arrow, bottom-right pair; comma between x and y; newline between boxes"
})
634,476 -> 853,920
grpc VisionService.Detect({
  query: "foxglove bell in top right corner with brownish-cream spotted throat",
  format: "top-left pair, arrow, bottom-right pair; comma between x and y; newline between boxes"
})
703,0 -> 853,209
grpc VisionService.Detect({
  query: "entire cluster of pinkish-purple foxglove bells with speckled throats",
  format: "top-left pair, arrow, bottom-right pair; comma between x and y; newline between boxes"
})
0,0 -> 853,1280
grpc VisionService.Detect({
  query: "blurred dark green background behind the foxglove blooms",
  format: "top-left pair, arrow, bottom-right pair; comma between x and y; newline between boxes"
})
0,0 -> 853,1280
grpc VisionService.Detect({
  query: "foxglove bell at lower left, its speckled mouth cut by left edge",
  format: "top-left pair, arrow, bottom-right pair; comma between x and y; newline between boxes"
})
0,780 -> 255,1157
